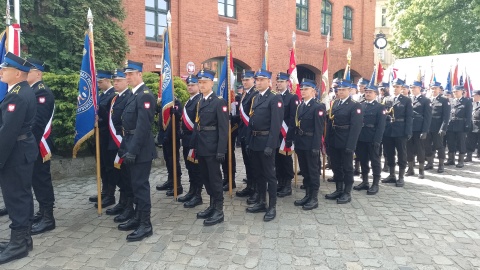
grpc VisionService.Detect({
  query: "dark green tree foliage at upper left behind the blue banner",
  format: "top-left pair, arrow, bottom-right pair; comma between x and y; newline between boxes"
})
0,0 -> 128,74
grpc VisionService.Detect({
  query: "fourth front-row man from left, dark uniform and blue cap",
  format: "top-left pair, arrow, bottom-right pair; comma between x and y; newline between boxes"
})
246,69 -> 283,221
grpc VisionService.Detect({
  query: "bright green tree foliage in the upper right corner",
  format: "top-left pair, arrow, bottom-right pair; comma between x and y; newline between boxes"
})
388,0 -> 480,58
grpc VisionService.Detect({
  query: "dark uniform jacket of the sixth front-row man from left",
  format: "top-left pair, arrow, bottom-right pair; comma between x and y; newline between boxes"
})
327,97 -> 363,150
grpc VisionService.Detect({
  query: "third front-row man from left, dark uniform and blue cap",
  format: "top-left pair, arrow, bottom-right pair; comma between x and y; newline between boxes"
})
190,70 -> 228,226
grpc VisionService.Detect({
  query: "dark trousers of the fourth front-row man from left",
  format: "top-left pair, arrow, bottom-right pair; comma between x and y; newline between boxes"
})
250,151 -> 277,206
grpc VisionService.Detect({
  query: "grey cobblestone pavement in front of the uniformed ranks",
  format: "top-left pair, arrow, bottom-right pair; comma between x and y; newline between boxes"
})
0,151 -> 480,269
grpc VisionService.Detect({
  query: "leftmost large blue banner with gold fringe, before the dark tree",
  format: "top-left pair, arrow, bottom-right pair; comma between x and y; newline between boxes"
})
73,34 -> 97,157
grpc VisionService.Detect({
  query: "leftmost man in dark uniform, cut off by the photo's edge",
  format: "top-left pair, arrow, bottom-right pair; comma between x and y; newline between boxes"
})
0,52 -> 38,264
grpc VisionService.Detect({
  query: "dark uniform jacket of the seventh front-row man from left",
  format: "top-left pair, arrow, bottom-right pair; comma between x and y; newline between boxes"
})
358,100 -> 387,143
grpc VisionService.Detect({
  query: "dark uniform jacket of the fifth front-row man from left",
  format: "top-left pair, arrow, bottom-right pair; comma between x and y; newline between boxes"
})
294,99 -> 327,150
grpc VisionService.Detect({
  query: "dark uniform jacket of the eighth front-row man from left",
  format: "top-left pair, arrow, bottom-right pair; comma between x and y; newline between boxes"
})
383,95 -> 413,137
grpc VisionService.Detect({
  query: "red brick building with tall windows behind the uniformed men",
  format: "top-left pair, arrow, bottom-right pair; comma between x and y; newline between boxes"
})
120,0 -> 375,87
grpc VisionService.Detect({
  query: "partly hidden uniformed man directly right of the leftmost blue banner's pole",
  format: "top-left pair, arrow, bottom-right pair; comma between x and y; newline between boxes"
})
89,70 -> 115,207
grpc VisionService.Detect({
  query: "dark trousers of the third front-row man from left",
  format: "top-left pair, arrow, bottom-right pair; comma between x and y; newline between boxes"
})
198,156 -> 223,202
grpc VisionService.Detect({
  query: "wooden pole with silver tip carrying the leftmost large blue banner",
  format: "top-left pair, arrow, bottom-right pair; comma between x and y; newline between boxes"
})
87,8 -> 102,216
